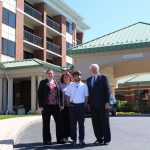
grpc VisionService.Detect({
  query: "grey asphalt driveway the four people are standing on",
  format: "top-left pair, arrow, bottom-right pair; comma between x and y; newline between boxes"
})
14,117 -> 150,150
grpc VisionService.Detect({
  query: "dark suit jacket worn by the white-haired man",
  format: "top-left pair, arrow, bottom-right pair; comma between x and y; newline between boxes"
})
87,75 -> 110,109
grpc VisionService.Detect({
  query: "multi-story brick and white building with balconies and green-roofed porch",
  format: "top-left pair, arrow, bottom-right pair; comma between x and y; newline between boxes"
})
0,0 -> 89,112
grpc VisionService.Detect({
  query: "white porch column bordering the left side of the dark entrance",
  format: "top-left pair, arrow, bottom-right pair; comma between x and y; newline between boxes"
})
8,78 -> 13,113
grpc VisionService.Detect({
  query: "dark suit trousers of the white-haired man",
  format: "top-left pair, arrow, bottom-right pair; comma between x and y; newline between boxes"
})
91,108 -> 111,142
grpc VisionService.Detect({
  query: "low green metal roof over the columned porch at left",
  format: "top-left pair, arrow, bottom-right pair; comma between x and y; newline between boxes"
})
0,58 -> 72,72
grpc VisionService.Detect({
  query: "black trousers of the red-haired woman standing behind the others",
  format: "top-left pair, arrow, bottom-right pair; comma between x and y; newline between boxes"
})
61,106 -> 71,138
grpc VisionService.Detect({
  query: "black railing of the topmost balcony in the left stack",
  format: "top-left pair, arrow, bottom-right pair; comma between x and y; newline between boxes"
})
24,3 -> 42,21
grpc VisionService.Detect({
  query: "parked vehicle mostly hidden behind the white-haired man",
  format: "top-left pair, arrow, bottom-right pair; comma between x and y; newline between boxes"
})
109,95 -> 117,116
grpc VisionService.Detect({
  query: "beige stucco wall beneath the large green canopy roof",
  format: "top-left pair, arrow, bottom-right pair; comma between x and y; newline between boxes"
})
72,48 -> 150,94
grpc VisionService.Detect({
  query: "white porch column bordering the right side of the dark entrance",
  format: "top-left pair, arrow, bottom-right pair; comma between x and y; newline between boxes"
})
30,76 -> 37,113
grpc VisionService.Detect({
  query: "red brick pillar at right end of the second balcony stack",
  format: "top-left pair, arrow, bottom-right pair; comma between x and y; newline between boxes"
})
53,16 -> 66,66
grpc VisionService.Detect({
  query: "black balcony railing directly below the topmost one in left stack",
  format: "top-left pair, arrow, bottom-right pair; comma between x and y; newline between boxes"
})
24,30 -> 42,47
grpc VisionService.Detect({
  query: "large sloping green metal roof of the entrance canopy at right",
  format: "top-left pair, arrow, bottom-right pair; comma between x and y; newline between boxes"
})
67,22 -> 150,55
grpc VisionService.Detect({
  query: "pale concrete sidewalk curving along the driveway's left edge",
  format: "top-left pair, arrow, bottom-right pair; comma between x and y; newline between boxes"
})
0,115 -> 42,150
